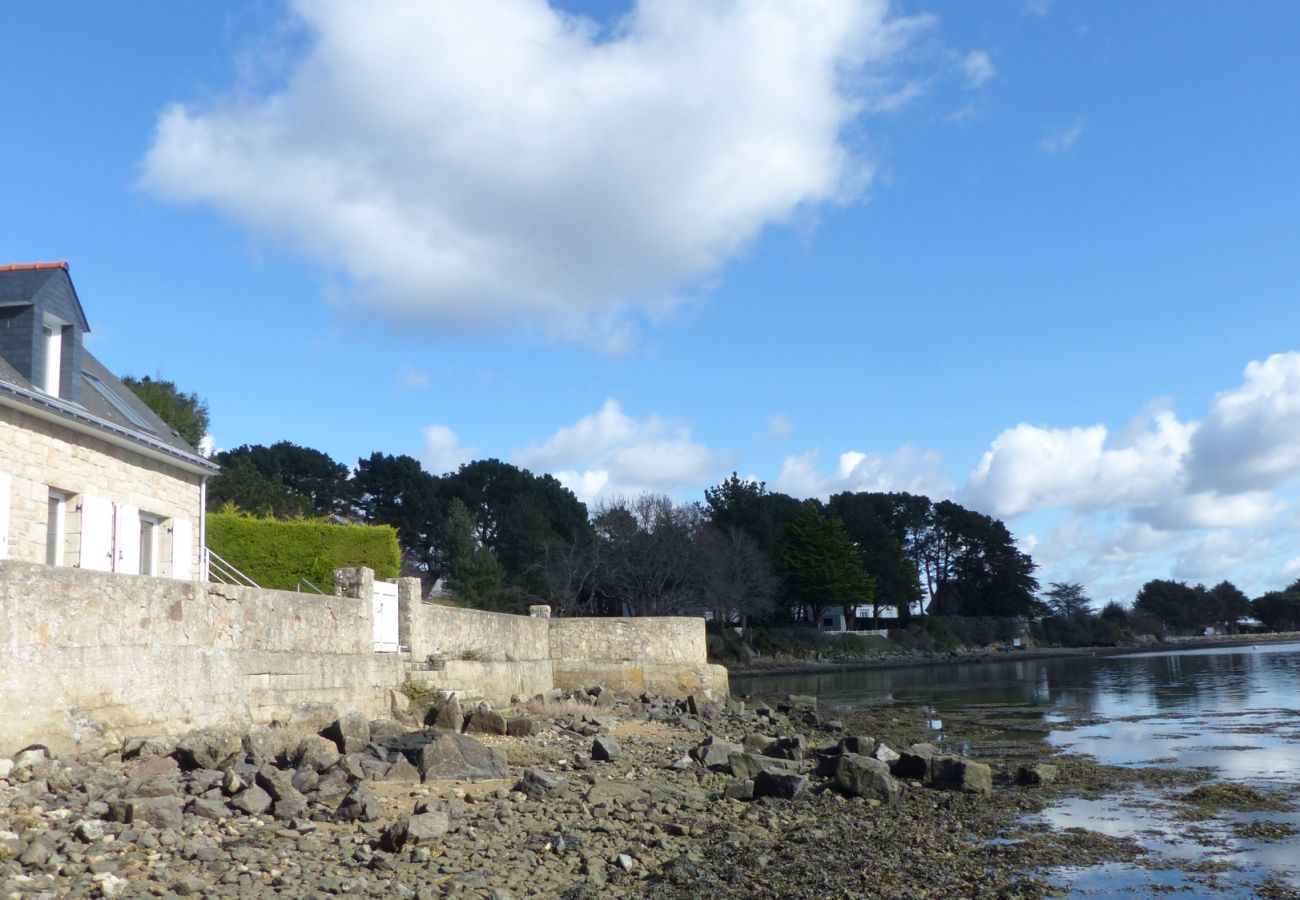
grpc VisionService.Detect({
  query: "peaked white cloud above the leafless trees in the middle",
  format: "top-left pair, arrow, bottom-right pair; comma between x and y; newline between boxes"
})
514,398 -> 719,502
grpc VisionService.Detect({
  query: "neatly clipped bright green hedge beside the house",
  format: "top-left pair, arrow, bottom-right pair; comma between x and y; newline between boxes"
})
208,512 -> 402,593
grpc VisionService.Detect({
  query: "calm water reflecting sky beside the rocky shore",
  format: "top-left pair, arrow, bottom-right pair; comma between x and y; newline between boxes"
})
732,644 -> 1300,896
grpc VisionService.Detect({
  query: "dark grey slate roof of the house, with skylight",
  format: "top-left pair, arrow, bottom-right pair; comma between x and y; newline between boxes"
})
0,263 -> 218,472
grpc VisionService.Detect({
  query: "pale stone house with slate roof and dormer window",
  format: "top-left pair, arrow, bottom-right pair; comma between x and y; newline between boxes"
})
0,263 -> 217,580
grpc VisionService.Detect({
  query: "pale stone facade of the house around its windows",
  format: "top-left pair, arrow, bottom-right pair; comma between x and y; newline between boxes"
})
0,406 -> 203,576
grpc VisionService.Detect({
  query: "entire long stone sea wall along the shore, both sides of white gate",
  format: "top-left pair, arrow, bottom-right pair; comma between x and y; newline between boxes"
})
0,561 -> 727,754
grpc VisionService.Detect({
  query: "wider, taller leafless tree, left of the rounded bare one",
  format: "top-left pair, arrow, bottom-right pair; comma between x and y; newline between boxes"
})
593,493 -> 703,615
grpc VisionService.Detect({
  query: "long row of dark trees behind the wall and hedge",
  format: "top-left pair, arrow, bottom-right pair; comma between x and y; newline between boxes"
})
200,441 -> 1043,628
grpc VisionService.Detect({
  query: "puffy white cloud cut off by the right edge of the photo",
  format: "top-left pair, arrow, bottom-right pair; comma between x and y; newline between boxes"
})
1188,351 -> 1300,492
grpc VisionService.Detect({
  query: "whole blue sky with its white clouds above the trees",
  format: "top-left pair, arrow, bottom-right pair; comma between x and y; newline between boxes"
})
0,0 -> 1300,601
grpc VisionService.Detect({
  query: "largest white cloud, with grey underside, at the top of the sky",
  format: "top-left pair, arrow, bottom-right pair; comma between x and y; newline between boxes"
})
142,0 -> 933,347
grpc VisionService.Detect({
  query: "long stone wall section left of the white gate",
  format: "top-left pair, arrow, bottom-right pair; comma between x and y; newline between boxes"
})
0,561 -> 406,754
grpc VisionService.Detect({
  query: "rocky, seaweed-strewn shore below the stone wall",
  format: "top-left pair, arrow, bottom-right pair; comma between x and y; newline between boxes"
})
0,688 -> 1159,900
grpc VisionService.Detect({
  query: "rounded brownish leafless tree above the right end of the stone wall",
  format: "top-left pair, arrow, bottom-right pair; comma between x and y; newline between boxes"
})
696,525 -> 780,631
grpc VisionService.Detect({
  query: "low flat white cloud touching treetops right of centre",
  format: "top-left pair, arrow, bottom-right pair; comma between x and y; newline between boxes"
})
772,445 -> 953,499
